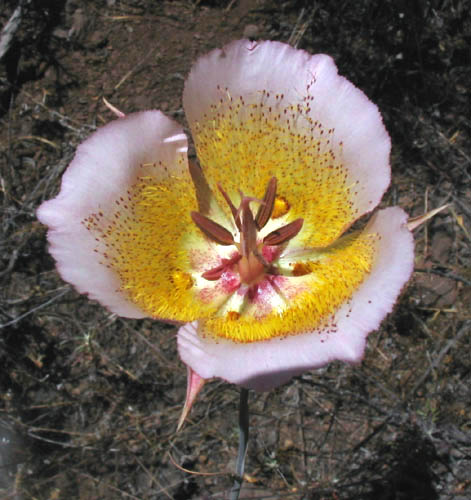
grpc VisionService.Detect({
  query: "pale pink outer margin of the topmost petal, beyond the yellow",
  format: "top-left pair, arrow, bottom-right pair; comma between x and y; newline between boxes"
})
183,40 -> 390,222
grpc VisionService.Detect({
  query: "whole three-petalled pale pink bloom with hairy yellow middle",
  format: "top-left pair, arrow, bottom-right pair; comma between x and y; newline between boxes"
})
38,40 -> 413,392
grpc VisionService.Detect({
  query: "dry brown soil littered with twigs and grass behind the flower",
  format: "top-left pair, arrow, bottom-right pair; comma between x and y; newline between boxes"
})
0,0 -> 471,500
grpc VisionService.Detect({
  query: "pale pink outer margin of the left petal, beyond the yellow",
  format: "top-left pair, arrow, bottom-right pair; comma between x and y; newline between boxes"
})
37,111 -> 187,318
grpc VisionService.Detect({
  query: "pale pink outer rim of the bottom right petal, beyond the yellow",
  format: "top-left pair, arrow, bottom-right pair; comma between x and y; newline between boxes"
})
178,207 -> 414,391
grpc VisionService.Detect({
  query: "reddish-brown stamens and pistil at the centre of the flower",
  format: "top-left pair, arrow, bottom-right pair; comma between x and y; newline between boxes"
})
191,177 -> 304,287
